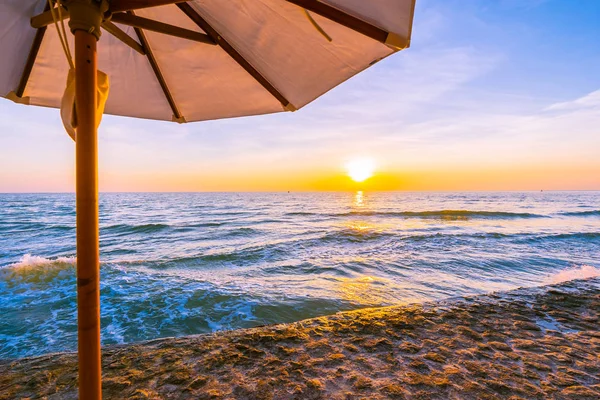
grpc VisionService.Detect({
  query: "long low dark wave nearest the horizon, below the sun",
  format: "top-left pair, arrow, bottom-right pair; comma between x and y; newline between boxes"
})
285,210 -> 548,219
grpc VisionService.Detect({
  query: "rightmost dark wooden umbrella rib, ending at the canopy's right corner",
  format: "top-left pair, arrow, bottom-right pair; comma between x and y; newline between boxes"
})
286,0 -> 408,48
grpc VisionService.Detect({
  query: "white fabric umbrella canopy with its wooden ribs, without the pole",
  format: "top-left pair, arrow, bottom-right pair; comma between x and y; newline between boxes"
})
0,0 -> 414,122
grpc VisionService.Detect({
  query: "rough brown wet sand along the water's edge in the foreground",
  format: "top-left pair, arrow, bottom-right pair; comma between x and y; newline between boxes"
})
0,278 -> 600,399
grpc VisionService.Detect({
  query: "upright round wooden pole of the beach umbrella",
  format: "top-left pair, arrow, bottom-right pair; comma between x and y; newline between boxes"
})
74,30 -> 102,400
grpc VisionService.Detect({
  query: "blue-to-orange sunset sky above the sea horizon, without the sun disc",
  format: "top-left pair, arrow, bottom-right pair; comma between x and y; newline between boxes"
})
0,0 -> 600,192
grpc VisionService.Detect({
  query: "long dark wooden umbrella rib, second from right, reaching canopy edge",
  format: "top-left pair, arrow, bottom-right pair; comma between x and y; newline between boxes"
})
177,3 -> 296,111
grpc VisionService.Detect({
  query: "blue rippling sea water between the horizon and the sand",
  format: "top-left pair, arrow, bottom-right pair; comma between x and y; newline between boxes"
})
0,192 -> 600,358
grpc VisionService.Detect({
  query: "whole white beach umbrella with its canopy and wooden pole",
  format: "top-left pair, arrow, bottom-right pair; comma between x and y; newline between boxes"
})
0,0 -> 415,399
